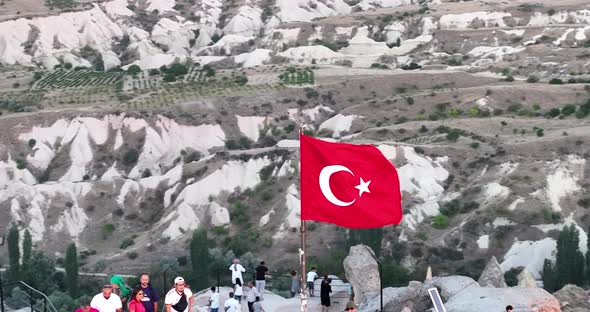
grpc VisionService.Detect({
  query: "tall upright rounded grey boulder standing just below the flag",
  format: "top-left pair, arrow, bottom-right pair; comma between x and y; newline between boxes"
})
343,245 -> 380,304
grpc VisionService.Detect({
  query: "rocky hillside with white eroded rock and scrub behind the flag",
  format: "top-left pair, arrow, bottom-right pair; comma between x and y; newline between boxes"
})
0,0 -> 590,286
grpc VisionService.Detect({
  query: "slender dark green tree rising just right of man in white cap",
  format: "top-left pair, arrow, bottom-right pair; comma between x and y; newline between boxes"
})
190,229 -> 209,289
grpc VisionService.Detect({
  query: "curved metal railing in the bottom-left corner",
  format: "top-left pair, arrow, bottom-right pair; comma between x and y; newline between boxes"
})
0,281 -> 58,312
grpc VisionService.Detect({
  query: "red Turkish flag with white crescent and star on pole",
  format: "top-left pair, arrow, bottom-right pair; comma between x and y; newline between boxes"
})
300,135 -> 402,228
